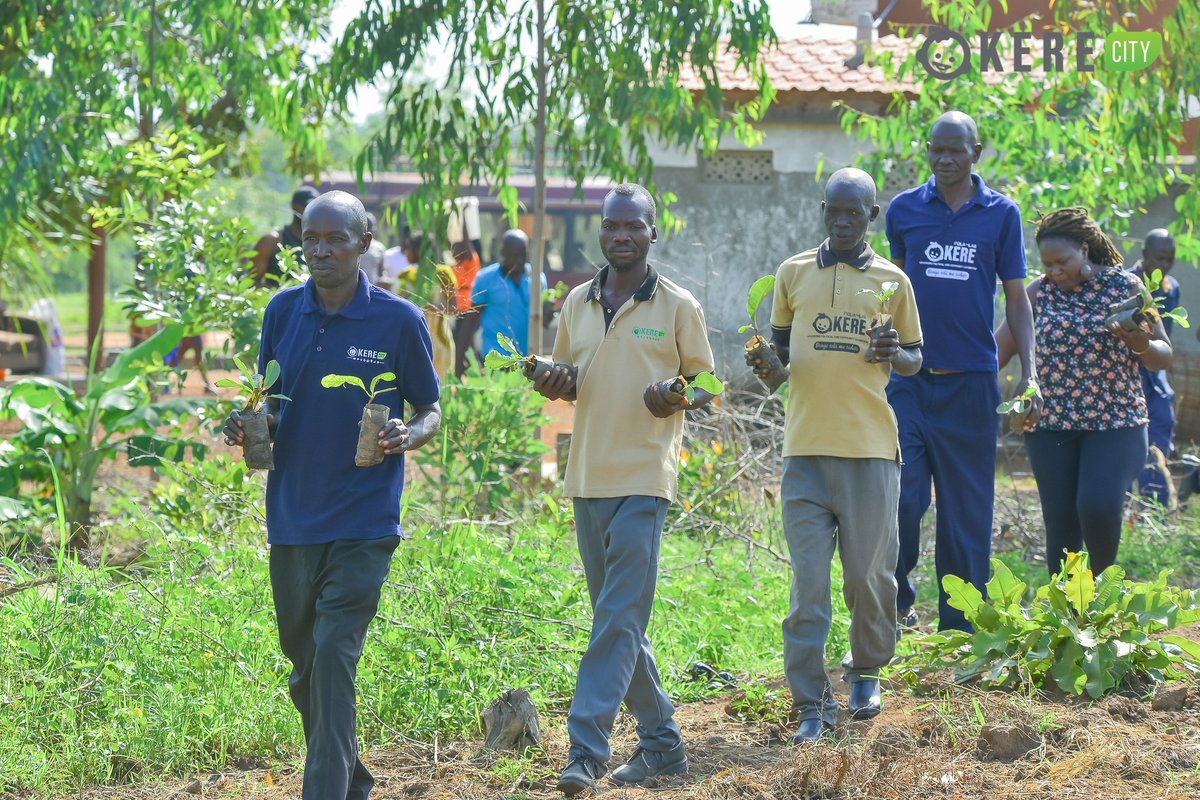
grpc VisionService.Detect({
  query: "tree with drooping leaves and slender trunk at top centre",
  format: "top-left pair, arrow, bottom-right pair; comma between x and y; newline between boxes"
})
317,0 -> 774,353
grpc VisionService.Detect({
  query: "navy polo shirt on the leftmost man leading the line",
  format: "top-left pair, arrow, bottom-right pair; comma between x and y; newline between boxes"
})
259,270 -> 439,545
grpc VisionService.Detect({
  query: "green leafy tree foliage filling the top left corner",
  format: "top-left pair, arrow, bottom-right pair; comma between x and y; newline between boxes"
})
0,0 -> 332,347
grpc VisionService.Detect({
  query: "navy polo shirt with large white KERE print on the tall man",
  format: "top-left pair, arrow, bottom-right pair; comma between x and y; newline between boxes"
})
886,175 -> 1025,372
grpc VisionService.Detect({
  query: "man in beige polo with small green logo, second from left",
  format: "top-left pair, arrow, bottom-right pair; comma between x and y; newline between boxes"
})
535,184 -> 713,795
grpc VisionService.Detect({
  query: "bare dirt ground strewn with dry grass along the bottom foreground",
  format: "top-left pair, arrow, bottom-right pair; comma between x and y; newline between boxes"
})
51,626 -> 1200,800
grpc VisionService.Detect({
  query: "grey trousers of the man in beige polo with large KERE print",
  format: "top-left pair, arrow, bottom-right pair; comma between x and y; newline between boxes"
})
781,456 -> 900,724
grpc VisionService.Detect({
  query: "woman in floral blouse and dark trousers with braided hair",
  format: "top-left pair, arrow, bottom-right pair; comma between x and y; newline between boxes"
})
996,206 -> 1171,575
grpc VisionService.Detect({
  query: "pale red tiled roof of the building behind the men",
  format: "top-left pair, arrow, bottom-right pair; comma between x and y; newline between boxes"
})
680,36 -> 917,95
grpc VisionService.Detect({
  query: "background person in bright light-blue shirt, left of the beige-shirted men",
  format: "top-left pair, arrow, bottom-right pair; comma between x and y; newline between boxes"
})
470,229 -> 546,357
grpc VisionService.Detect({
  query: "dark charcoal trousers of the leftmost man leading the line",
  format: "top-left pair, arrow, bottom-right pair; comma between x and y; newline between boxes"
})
270,536 -> 400,800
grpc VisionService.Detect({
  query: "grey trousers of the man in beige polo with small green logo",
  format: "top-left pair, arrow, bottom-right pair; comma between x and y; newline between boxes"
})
566,497 -> 680,764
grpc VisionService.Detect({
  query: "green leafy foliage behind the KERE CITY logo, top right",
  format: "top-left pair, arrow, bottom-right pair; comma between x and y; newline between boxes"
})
842,0 -> 1200,261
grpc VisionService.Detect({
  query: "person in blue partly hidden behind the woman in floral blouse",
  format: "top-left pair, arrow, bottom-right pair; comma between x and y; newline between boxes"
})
1133,228 -> 1180,507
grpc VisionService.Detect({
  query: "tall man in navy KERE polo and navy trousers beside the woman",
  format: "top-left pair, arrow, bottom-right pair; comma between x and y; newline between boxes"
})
887,112 -> 1042,630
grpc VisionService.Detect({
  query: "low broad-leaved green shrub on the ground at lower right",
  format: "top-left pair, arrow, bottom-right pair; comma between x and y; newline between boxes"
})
900,553 -> 1200,698
